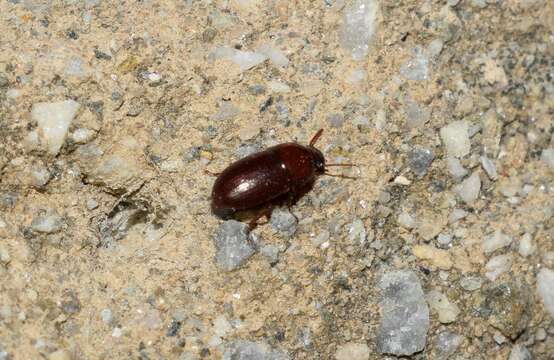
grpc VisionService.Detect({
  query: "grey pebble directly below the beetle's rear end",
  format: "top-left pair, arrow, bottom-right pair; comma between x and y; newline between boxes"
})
213,220 -> 254,271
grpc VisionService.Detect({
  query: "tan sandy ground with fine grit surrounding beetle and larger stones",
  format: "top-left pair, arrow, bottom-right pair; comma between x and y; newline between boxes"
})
0,0 -> 554,359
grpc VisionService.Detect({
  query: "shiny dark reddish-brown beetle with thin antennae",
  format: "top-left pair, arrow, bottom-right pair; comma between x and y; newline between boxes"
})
211,129 -> 354,229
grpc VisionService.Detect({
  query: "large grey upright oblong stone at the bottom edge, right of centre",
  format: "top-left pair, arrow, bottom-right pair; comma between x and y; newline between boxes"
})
377,270 -> 429,356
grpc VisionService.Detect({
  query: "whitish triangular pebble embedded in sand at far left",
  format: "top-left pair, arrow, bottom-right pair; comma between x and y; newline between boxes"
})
31,100 -> 80,156
